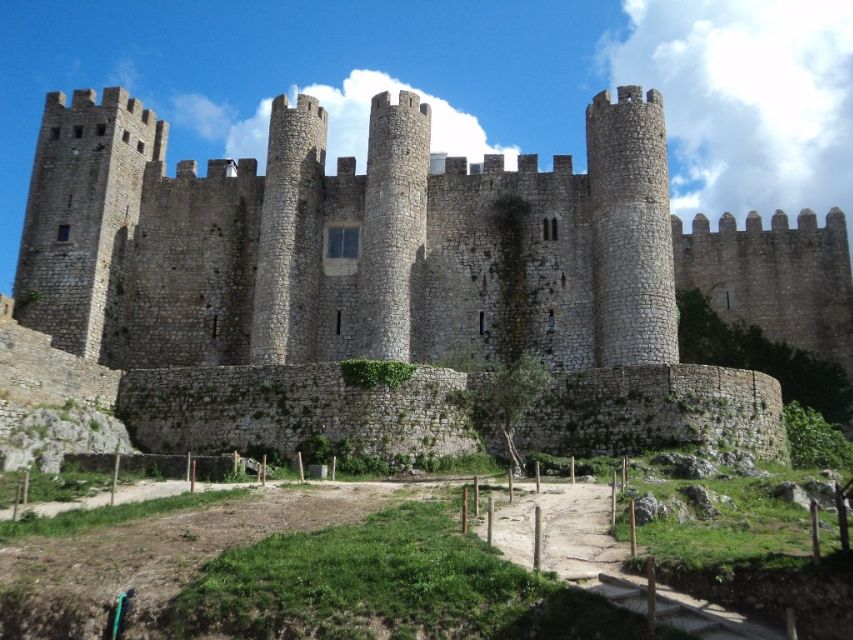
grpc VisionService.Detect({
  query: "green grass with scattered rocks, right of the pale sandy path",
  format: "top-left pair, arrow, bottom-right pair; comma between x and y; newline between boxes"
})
616,460 -> 840,569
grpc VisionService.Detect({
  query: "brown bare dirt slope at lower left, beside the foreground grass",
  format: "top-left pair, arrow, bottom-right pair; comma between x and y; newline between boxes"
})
0,483 -> 399,640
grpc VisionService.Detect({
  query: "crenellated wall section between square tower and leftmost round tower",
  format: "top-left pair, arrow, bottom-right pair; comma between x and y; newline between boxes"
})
107,160 -> 264,368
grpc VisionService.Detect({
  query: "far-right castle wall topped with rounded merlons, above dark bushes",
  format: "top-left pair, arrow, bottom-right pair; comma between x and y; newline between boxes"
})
673,209 -> 853,375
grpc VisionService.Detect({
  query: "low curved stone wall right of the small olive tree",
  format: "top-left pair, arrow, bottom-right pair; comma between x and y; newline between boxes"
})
471,364 -> 788,460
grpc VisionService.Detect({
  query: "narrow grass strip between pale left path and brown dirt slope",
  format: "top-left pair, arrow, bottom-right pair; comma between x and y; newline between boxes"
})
0,489 -> 249,543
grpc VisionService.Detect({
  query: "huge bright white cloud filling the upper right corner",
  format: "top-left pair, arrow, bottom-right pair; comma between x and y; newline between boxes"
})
601,0 -> 853,228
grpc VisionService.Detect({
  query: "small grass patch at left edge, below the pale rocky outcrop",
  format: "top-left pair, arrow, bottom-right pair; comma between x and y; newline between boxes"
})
0,469 -> 155,509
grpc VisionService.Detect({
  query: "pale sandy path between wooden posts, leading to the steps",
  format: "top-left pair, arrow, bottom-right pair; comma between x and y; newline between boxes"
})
477,483 -> 630,580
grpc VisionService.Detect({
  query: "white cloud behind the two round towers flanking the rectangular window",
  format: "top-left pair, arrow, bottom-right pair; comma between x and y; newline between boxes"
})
226,69 -> 519,175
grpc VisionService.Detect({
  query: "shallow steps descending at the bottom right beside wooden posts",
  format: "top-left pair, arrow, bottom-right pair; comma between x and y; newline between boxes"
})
584,573 -> 785,640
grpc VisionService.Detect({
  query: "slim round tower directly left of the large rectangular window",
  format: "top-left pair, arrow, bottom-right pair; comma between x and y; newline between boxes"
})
251,94 -> 329,364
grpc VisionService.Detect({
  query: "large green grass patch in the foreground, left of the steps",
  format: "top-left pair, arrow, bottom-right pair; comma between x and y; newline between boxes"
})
168,501 -> 689,640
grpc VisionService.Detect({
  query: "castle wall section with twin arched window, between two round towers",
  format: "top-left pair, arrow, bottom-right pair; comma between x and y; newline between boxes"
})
420,155 -> 594,370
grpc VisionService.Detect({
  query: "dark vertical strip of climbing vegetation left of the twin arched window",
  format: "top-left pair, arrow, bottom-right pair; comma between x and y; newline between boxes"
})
492,194 -> 533,365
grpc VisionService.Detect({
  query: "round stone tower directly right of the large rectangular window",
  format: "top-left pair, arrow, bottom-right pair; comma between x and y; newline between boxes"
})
359,91 -> 432,362
